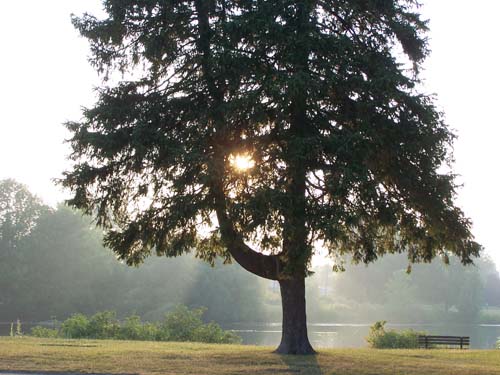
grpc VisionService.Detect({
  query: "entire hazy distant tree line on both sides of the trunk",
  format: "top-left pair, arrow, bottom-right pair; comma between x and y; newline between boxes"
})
0,180 -> 500,323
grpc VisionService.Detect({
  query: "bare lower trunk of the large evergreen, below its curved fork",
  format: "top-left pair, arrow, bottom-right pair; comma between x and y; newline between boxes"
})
276,278 -> 316,354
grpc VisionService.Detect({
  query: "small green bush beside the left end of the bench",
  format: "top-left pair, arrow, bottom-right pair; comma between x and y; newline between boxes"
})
366,321 -> 423,349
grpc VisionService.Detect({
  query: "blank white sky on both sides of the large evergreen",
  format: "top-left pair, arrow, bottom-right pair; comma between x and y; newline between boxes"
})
0,0 -> 500,268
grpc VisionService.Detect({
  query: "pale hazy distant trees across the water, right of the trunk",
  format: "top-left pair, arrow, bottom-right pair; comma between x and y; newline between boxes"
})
309,255 -> 500,323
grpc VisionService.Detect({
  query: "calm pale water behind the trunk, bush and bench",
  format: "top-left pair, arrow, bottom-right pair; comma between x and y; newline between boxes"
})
224,323 -> 500,349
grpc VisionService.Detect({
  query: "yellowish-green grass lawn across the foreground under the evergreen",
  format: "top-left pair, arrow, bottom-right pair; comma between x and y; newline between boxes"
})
0,338 -> 500,375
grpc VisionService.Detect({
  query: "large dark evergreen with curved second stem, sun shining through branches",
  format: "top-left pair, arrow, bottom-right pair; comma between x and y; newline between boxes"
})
64,0 -> 480,353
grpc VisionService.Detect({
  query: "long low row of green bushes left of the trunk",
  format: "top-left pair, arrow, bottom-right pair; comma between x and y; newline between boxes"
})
31,305 -> 241,344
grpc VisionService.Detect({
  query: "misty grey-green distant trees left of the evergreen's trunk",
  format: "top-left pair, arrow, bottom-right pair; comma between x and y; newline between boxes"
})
0,180 -> 265,322
